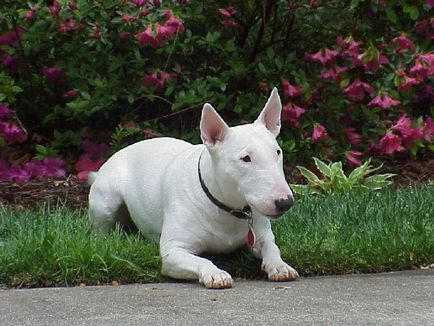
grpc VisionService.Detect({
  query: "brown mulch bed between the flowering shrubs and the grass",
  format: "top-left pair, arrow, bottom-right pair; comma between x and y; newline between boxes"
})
0,158 -> 434,209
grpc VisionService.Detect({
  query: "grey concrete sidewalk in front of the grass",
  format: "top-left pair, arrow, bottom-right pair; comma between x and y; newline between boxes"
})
0,270 -> 434,326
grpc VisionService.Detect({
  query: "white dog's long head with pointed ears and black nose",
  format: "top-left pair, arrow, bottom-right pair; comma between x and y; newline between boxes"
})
200,88 -> 294,218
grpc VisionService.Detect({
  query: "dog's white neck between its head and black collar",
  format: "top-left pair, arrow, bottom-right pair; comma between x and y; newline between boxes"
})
199,149 -> 247,209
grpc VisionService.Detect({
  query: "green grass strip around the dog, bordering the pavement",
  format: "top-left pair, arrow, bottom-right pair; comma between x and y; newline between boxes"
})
0,186 -> 434,287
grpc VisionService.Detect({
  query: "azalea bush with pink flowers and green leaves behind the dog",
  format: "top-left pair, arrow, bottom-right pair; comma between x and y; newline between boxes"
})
0,0 -> 434,180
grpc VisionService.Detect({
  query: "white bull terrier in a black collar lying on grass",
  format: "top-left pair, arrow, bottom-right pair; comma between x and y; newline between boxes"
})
89,89 -> 298,288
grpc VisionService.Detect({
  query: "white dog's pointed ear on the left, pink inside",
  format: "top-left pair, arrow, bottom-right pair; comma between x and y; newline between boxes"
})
200,103 -> 229,146
